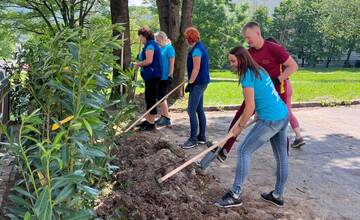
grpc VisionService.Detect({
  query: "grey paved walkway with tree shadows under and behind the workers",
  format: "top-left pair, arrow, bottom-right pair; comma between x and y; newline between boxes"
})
161,106 -> 360,219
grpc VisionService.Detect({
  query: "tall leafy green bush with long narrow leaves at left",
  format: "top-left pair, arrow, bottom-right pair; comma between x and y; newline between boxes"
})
1,26 -> 134,220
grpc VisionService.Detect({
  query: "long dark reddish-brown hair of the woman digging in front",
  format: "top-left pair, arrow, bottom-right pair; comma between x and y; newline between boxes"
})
229,46 -> 262,81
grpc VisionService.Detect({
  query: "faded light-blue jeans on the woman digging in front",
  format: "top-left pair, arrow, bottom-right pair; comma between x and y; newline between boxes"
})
232,117 -> 288,196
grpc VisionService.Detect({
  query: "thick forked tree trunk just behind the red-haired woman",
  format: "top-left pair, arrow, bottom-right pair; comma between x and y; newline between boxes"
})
156,0 -> 193,98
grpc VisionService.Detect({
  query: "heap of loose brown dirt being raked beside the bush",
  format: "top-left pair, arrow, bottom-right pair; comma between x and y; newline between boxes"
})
96,131 -> 311,219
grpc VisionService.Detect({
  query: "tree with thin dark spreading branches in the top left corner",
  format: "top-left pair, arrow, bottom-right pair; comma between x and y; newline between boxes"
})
0,0 -> 102,34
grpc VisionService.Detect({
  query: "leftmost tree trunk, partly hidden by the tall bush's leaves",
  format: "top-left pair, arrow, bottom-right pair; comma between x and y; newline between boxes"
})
110,0 -> 131,99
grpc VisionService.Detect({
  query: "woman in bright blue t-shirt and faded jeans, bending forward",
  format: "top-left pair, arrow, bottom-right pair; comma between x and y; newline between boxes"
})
215,46 -> 288,207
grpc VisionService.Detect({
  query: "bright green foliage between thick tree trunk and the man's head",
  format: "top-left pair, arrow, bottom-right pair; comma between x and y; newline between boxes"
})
192,0 -> 247,68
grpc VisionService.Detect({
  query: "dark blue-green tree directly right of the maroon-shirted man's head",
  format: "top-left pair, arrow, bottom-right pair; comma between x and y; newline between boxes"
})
271,0 -> 324,66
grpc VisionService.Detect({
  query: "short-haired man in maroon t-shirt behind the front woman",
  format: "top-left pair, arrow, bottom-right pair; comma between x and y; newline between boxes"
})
218,22 -> 305,162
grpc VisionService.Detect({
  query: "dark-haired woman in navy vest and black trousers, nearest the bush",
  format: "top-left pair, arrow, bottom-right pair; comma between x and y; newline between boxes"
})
135,27 -> 162,131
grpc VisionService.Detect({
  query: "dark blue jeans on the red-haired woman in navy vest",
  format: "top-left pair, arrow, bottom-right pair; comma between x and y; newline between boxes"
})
187,84 -> 207,142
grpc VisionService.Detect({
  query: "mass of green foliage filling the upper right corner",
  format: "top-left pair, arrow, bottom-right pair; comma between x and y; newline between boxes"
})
270,0 -> 360,66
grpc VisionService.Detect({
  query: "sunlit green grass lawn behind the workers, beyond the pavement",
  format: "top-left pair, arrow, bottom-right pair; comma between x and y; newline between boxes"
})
138,68 -> 360,107
